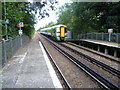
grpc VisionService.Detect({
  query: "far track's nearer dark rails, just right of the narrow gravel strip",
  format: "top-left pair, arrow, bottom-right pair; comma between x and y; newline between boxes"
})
59,43 -> 120,77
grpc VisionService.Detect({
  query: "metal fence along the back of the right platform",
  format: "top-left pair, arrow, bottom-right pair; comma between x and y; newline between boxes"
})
73,33 -> 120,42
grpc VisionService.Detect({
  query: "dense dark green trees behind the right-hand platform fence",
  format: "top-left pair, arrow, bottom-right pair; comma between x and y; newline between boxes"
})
58,2 -> 120,34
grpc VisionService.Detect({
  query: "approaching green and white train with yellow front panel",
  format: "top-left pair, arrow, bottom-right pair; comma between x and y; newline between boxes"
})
40,24 -> 68,41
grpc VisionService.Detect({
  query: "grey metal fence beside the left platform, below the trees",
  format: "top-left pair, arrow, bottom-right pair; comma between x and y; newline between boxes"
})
0,35 -> 29,66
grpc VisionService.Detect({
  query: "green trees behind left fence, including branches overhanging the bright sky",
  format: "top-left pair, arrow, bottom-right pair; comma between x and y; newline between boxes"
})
2,0 -> 57,38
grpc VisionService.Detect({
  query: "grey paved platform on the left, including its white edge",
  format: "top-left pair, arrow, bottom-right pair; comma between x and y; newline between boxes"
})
1,33 -> 62,88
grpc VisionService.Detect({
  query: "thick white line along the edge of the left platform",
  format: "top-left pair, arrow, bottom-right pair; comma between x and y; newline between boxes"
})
39,41 -> 62,88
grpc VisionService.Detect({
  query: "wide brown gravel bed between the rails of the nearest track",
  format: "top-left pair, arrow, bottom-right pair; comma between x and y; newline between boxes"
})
40,36 -> 100,88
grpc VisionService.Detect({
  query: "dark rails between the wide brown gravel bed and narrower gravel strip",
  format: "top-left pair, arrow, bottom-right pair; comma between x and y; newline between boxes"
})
40,34 -> 120,89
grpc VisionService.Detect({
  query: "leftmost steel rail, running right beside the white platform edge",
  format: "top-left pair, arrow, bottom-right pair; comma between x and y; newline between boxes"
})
40,37 -> 72,90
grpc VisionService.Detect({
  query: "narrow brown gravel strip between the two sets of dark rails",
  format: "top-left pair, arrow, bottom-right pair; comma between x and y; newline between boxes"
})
59,43 -> 120,85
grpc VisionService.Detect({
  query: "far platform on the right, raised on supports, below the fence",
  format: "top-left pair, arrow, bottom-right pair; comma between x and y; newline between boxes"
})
68,39 -> 120,58
